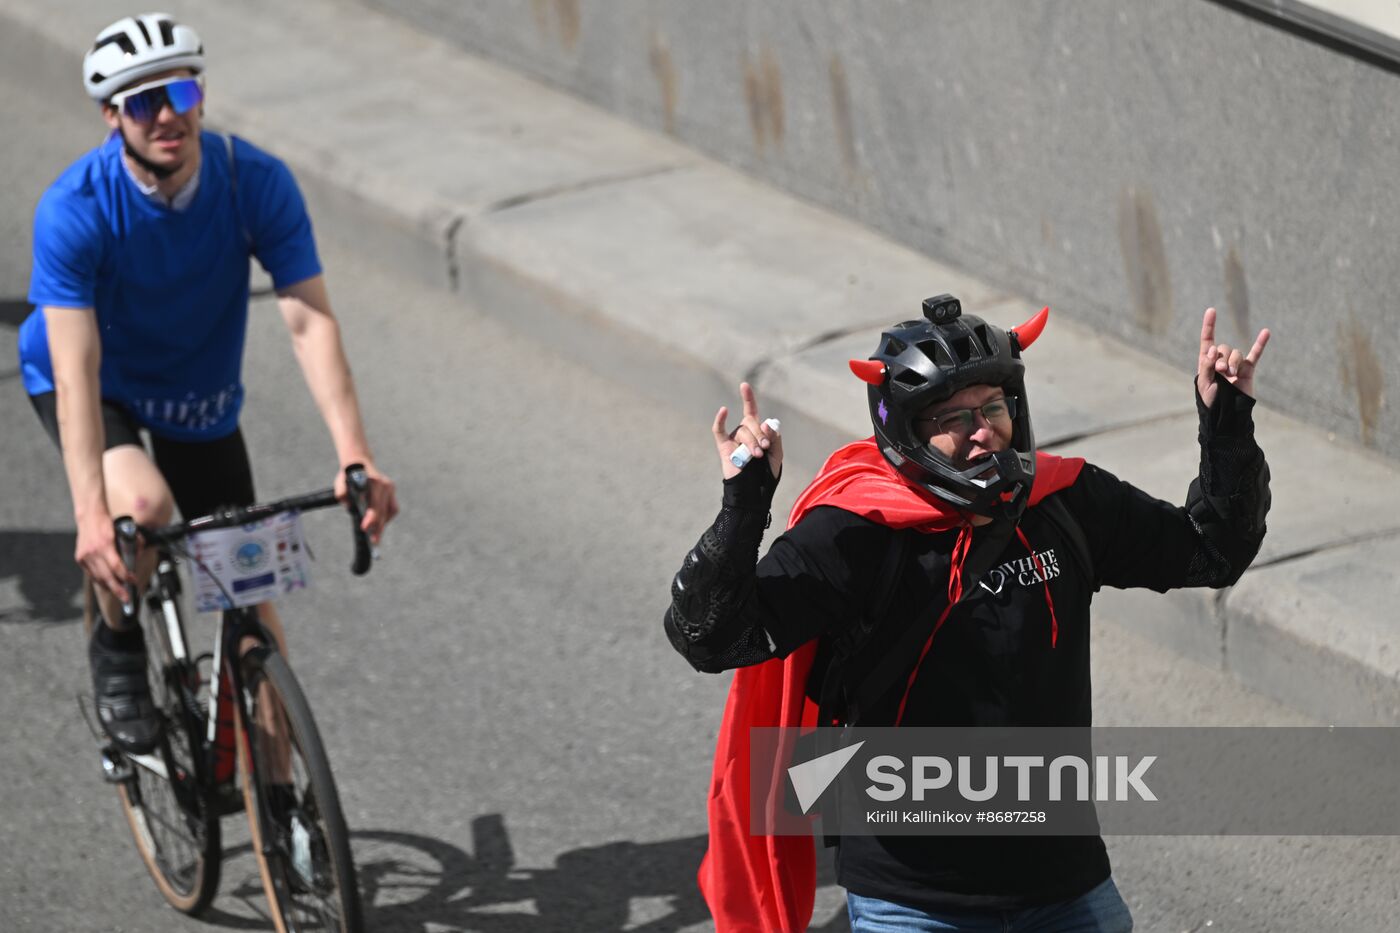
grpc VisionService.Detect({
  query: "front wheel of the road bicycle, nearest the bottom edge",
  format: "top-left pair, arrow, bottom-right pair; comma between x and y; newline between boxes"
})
237,646 -> 364,933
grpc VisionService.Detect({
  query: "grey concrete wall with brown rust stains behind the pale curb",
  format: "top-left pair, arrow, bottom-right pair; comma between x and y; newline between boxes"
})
365,0 -> 1400,457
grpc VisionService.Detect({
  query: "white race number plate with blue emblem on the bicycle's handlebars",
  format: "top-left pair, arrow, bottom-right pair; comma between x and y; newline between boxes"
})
189,511 -> 311,612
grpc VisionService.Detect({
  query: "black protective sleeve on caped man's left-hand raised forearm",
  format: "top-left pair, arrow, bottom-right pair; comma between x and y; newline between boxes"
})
665,459 -> 778,674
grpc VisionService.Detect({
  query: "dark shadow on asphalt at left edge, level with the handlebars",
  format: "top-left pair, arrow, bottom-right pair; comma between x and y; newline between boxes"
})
0,531 -> 83,623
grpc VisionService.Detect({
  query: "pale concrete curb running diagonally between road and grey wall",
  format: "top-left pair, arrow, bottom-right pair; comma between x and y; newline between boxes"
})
0,0 -> 1400,724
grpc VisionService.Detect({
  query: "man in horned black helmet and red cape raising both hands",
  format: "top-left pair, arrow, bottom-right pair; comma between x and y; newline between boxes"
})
665,296 -> 1268,933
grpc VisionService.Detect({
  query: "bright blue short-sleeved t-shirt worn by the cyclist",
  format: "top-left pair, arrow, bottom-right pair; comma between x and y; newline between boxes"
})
20,133 -> 321,441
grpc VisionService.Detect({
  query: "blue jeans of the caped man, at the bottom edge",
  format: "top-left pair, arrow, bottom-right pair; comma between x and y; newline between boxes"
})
846,878 -> 1133,933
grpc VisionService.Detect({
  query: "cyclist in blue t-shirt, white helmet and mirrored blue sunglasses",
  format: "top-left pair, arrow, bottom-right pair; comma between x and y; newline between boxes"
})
20,13 -> 398,752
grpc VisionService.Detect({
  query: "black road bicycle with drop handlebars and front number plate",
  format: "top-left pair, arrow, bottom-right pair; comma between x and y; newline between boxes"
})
84,465 -> 372,933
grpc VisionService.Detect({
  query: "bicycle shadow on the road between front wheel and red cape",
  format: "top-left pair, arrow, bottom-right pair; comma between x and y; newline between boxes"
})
202,814 -> 850,933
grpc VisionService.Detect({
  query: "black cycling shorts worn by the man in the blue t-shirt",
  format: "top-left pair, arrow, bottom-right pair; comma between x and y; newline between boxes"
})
29,392 -> 256,520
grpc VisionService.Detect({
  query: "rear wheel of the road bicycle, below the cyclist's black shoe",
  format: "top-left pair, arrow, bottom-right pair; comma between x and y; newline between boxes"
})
83,583 -> 223,916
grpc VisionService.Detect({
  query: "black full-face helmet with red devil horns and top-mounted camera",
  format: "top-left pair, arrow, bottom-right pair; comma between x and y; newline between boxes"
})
851,294 -> 1050,521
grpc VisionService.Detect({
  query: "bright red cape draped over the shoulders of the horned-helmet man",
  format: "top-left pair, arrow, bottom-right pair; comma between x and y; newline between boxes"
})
699,437 -> 1084,933
